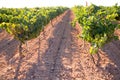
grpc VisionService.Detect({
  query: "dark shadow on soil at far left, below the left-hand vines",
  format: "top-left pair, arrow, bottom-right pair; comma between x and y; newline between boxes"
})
0,39 -> 19,64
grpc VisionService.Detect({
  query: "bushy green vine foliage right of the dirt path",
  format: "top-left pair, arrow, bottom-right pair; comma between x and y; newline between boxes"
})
72,4 -> 120,54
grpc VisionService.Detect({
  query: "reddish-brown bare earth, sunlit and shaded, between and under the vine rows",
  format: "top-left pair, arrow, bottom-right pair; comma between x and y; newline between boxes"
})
0,11 -> 120,80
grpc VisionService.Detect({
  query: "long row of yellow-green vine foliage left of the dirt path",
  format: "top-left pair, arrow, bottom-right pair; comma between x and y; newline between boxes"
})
0,7 -> 67,43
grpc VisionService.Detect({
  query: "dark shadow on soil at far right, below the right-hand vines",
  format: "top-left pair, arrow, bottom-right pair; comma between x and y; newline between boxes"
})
98,40 -> 120,80
